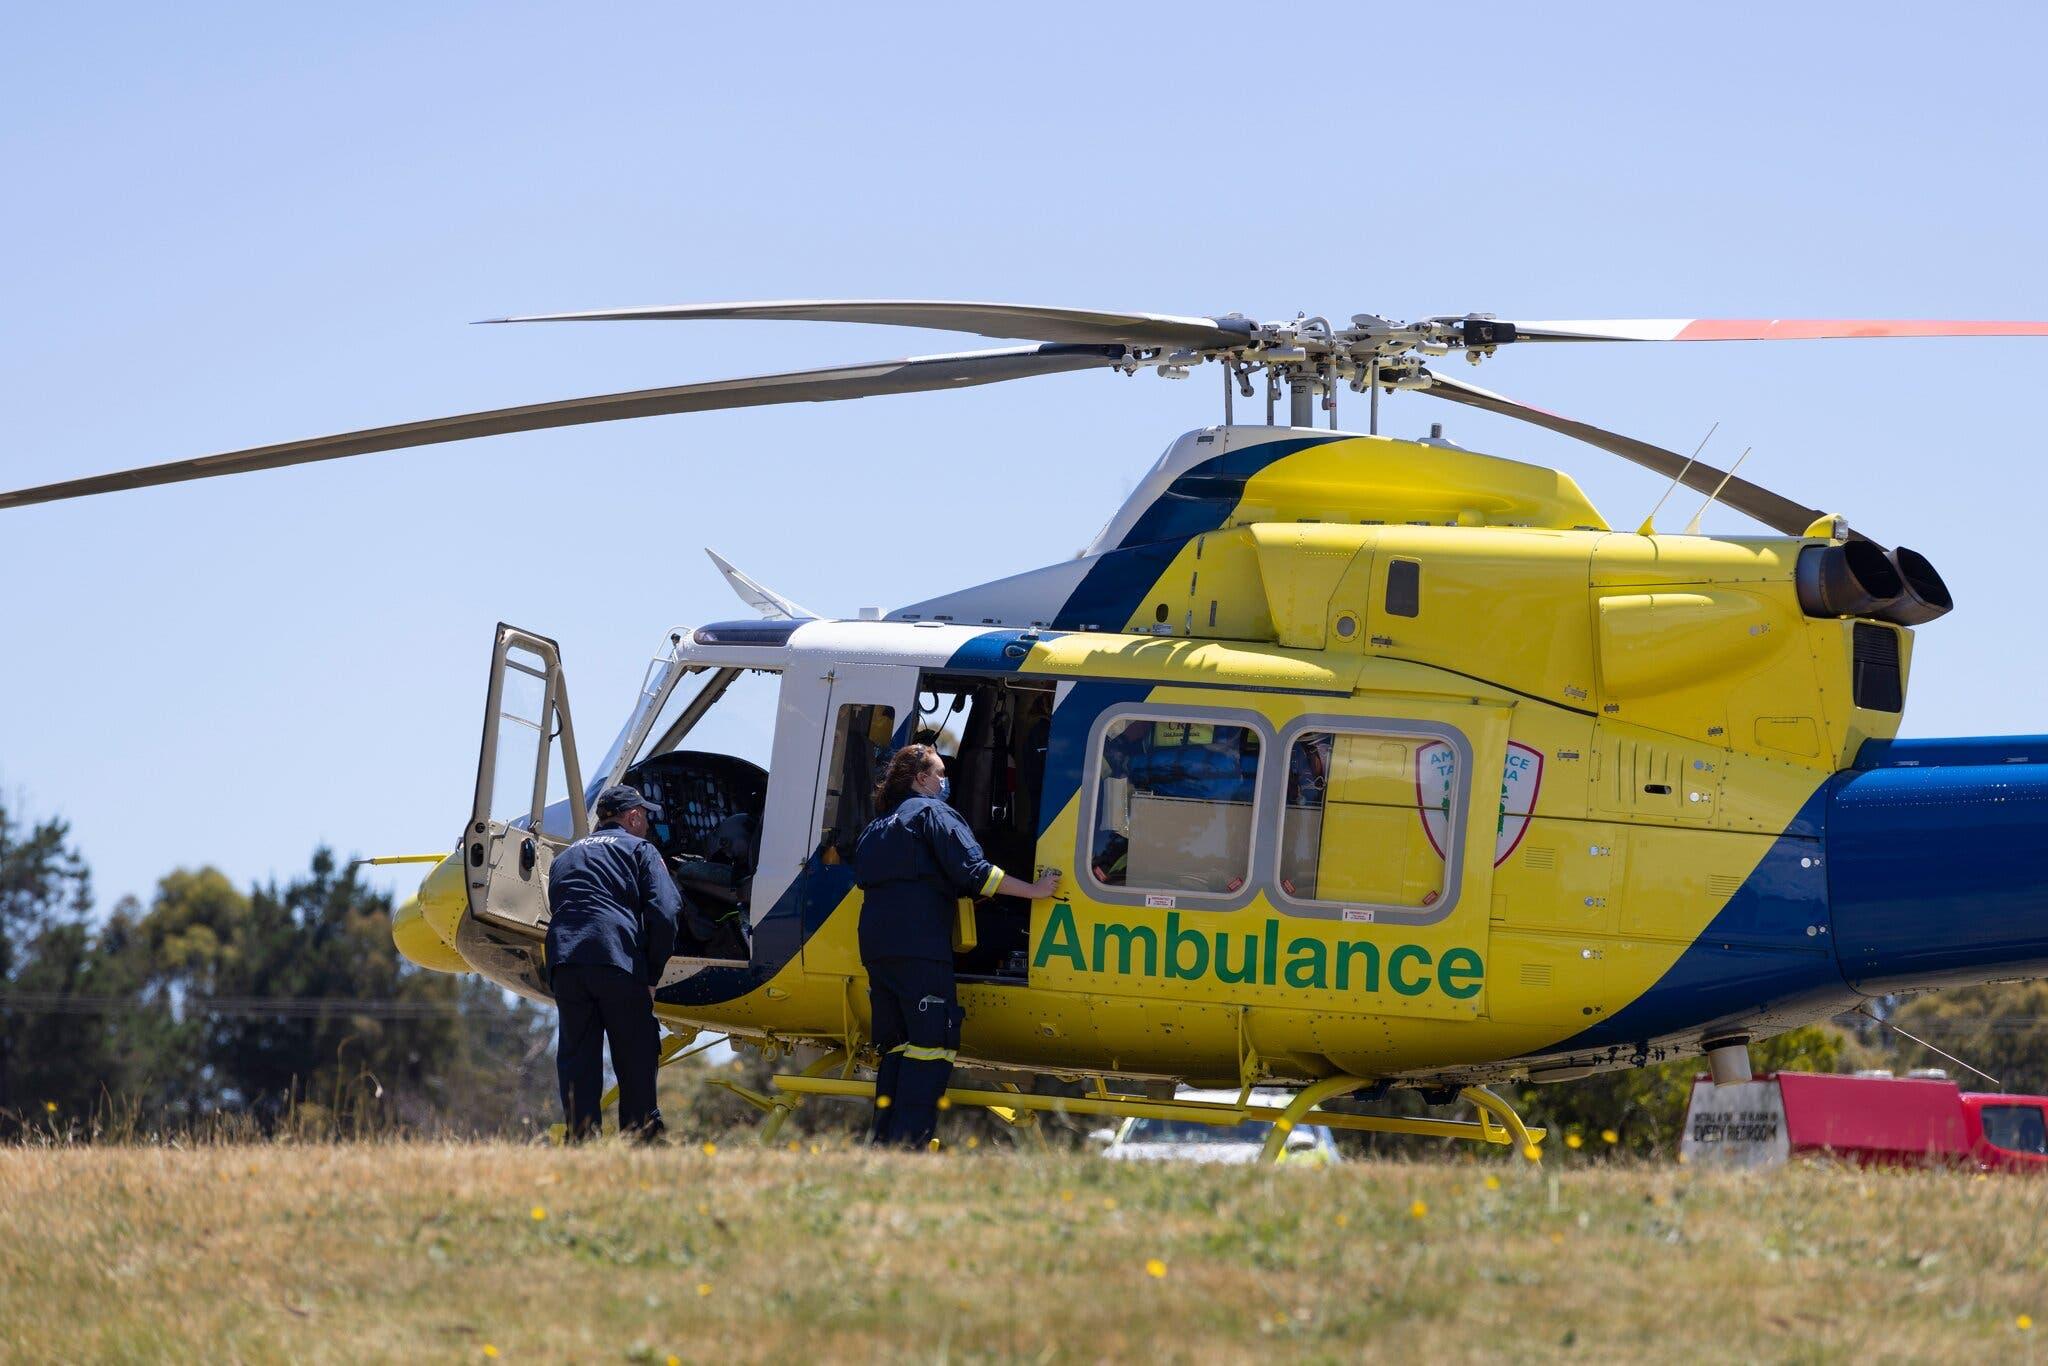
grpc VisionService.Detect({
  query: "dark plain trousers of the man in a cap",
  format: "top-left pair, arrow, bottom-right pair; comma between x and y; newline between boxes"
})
549,963 -> 662,1143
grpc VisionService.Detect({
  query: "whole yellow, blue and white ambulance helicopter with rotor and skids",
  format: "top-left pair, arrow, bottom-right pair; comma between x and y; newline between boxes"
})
16,301 -> 2048,1159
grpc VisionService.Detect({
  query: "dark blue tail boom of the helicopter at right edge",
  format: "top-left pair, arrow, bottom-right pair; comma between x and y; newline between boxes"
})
1827,735 -> 2048,995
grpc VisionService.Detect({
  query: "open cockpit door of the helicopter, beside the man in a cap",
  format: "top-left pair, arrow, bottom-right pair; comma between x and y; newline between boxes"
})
463,623 -> 590,938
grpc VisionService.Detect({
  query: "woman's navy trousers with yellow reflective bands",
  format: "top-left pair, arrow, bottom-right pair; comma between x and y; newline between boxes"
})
866,958 -> 967,1149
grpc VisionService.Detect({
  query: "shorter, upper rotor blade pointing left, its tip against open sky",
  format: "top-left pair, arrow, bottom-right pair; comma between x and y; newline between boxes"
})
485,299 -> 1251,346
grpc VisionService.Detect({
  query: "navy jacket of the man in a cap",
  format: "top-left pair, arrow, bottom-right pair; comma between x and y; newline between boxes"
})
547,821 -> 682,987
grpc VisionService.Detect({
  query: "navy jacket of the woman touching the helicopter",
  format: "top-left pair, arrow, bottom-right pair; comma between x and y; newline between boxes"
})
854,797 -> 1004,965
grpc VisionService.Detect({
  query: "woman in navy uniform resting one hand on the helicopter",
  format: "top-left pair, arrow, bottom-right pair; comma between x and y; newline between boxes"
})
854,745 -> 1059,1149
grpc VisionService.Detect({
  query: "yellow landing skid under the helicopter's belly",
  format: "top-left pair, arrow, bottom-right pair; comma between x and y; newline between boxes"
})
757,1075 -> 1544,1161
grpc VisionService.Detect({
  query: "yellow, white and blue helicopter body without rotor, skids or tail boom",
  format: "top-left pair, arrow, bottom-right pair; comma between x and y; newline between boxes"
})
397,428 -> 2038,1085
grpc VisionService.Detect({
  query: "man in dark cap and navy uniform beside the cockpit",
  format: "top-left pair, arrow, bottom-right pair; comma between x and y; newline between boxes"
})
547,784 -> 682,1143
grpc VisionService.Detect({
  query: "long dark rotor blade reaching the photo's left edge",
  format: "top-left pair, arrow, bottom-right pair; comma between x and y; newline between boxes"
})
0,346 -> 1124,508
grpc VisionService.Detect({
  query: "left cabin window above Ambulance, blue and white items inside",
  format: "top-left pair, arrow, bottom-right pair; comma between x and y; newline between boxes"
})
1087,717 -> 1264,897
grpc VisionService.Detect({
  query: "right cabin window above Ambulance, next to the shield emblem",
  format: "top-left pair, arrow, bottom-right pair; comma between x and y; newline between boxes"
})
1278,729 -> 1462,909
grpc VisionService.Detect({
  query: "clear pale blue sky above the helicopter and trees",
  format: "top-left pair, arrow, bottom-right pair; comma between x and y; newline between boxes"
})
0,4 -> 2048,905
